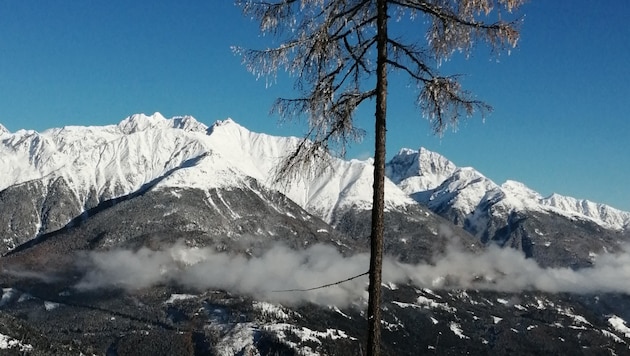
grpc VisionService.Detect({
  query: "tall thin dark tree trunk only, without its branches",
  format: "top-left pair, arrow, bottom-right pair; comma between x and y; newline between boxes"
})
367,0 -> 387,356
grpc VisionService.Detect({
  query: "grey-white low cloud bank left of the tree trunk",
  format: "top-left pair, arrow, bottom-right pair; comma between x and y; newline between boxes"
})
75,244 -> 376,305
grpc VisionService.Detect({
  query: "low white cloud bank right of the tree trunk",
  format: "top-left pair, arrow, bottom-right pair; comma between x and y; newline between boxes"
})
398,246 -> 630,294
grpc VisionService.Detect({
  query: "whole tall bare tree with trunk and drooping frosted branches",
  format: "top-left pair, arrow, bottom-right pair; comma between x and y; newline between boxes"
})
236,0 -> 524,355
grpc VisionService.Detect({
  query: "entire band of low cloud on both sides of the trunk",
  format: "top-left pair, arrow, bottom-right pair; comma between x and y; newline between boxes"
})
75,244 -> 630,305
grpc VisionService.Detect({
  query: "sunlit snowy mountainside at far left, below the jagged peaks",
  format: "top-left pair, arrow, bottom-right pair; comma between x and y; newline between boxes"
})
0,113 -> 212,204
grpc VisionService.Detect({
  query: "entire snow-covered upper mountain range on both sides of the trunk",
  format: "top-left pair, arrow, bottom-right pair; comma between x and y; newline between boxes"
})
0,113 -> 630,246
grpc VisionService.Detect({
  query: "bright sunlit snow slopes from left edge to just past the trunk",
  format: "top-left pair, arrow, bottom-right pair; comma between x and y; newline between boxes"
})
0,113 -> 415,225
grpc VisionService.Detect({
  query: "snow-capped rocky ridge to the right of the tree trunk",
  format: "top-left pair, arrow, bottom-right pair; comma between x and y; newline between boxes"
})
387,148 -> 630,230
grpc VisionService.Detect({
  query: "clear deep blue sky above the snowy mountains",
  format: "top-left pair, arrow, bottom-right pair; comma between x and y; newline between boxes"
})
0,0 -> 630,211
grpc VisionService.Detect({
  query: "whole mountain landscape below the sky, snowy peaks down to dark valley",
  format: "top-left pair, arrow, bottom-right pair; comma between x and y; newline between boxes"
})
0,114 -> 630,355
